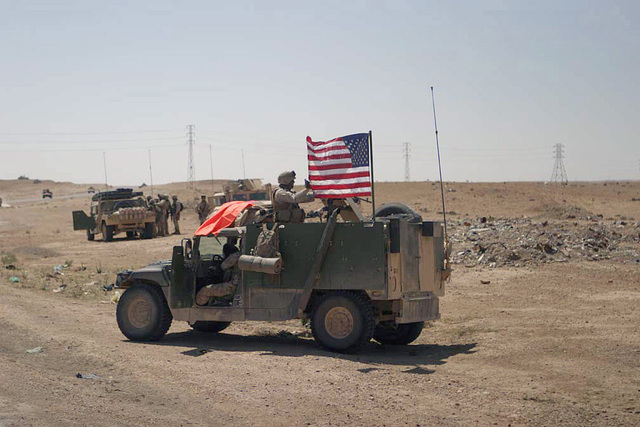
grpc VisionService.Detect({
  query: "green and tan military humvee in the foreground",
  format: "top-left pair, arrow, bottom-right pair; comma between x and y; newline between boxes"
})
116,204 -> 450,352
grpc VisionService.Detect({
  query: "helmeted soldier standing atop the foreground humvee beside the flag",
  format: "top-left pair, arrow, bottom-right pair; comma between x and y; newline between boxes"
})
273,171 -> 313,224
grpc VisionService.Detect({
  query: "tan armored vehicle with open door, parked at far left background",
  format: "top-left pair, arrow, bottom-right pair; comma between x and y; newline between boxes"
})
73,188 -> 155,242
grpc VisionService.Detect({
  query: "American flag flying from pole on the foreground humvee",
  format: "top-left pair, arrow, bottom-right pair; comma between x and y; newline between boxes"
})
307,133 -> 371,199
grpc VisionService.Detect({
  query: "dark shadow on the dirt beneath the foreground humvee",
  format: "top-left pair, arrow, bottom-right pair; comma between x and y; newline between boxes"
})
145,331 -> 477,374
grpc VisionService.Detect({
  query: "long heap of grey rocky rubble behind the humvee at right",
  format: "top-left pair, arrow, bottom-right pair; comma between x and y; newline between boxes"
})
448,217 -> 640,267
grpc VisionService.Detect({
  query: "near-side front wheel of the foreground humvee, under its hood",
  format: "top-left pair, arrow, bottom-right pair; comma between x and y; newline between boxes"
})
116,284 -> 173,341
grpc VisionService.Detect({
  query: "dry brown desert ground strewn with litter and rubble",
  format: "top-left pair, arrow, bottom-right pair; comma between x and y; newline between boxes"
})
0,180 -> 640,426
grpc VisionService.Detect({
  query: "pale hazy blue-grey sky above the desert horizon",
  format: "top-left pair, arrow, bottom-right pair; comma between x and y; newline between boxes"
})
0,0 -> 640,185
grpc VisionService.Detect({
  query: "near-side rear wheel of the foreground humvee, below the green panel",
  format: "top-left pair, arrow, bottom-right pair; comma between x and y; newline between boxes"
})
311,292 -> 375,353
